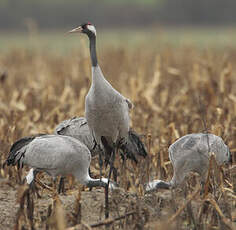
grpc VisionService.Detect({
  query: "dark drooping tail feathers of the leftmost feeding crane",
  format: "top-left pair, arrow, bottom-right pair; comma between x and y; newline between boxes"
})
3,134 -> 45,168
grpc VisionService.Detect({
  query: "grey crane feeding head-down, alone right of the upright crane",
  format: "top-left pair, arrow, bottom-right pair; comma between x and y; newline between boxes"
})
146,133 -> 232,192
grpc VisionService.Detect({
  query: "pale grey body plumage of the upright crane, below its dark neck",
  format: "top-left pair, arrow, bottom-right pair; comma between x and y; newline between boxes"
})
85,66 -> 132,150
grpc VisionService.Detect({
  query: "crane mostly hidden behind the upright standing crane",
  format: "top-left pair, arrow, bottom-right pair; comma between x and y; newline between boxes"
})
54,117 -> 147,163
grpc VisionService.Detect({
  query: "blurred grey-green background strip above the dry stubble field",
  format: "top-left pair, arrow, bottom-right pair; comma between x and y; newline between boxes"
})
0,0 -> 236,51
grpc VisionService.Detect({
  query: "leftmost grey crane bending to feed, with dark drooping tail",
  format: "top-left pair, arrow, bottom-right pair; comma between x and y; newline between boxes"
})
4,134 -> 115,188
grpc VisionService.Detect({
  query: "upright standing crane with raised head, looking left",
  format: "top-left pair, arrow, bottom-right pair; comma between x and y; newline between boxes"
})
69,23 -> 132,183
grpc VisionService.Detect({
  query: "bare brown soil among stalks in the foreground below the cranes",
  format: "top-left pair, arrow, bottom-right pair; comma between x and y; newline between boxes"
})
0,172 -> 235,230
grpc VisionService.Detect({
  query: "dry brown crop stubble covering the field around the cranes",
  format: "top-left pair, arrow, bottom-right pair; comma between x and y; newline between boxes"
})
0,41 -> 236,230
